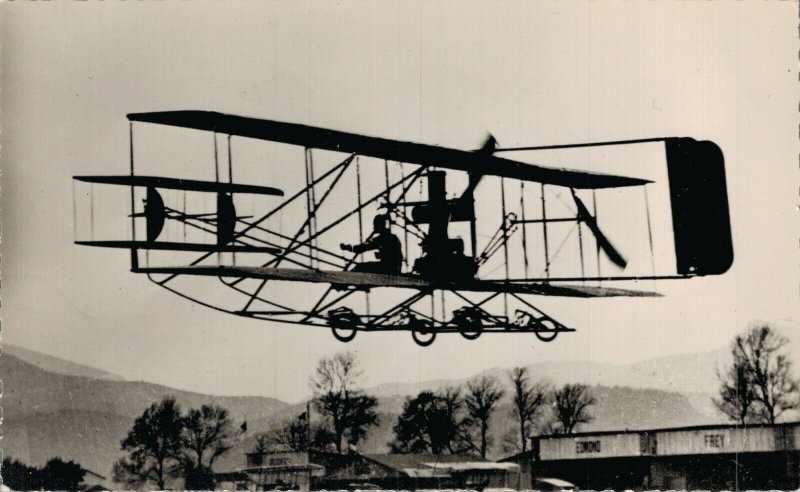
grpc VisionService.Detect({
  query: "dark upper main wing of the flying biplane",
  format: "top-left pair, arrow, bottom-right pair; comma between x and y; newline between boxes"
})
128,111 -> 650,189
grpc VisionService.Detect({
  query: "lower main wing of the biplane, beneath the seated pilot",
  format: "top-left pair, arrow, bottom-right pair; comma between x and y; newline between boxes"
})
137,266 -> 661,298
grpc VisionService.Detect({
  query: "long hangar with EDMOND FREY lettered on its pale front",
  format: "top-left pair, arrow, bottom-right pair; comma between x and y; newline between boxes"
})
501,422 -> 800,490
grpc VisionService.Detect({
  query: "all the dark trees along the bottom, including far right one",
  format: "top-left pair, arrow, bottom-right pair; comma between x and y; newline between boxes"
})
111,325 -> 800,490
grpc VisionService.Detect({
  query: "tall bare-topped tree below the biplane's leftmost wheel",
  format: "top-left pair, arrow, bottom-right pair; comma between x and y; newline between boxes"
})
311,352 -> 378,453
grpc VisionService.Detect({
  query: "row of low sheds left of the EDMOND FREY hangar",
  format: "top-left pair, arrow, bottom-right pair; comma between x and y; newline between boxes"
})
215,441 -> 520,492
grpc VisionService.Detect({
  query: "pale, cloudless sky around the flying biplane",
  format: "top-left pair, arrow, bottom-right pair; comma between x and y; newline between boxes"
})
0,1 -> 800,401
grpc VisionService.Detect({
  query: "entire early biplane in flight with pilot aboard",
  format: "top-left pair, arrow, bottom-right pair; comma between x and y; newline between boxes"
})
74,111 -> 733,346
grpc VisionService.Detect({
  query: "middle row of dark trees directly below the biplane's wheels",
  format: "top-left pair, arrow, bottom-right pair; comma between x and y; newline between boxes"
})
256,352 -> 596,458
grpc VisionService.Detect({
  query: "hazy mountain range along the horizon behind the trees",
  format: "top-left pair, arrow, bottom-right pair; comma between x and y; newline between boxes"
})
0,345 -> 736,488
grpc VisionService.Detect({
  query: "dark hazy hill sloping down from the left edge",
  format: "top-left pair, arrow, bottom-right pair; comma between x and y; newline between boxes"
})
0,351 -> 289,488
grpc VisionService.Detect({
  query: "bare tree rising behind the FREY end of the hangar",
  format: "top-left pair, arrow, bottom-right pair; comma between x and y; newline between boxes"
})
714,324 -> 800,424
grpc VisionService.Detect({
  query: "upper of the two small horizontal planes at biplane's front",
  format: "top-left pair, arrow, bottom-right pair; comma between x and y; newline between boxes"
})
73,176 -> 283,196
